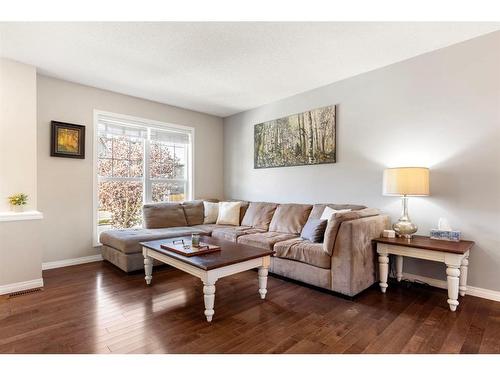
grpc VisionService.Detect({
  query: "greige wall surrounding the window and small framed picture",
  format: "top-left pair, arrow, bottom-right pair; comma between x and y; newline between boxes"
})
38,75 -> 223,262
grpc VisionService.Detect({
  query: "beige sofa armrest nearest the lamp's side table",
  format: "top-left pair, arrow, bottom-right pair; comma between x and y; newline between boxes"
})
331,215 -> 390,296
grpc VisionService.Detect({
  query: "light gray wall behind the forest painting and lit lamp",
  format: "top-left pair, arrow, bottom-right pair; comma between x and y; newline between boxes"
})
224,32 -> 500,291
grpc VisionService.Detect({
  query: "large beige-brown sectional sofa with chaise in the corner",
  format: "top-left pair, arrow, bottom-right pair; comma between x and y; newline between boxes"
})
100,201 -> 390,296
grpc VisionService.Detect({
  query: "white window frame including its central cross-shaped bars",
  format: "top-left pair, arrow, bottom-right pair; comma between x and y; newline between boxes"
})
92,109 -> 195,247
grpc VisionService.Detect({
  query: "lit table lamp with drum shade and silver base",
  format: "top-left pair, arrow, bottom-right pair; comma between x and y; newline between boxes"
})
383,167 -> 429,239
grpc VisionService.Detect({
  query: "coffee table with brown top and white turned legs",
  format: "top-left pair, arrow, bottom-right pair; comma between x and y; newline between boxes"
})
141,236 -> 274,322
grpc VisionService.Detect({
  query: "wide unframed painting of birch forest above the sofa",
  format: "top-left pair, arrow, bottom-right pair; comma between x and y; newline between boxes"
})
254,105 -> 336,168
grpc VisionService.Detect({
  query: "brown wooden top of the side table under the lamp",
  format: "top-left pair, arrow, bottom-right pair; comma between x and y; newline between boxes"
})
373,236 -> 474,254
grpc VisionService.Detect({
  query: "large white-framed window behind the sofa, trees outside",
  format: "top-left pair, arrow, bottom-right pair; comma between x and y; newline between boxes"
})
94,112 -> 193,243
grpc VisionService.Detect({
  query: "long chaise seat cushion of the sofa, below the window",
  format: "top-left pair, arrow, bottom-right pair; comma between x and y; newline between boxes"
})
99,227 -> 203,254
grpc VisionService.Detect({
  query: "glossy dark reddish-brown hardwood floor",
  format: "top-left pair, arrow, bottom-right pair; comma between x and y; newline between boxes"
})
0,262 -> 500,353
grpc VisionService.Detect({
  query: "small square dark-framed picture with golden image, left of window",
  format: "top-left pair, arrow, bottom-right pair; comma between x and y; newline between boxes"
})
50,121 -> 85,159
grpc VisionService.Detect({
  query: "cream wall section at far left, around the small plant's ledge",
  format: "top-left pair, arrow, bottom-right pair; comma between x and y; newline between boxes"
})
0,59 -> 42,294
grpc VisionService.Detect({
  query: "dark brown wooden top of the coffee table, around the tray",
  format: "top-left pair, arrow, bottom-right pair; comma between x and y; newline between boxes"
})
141,236 -> 274,271
